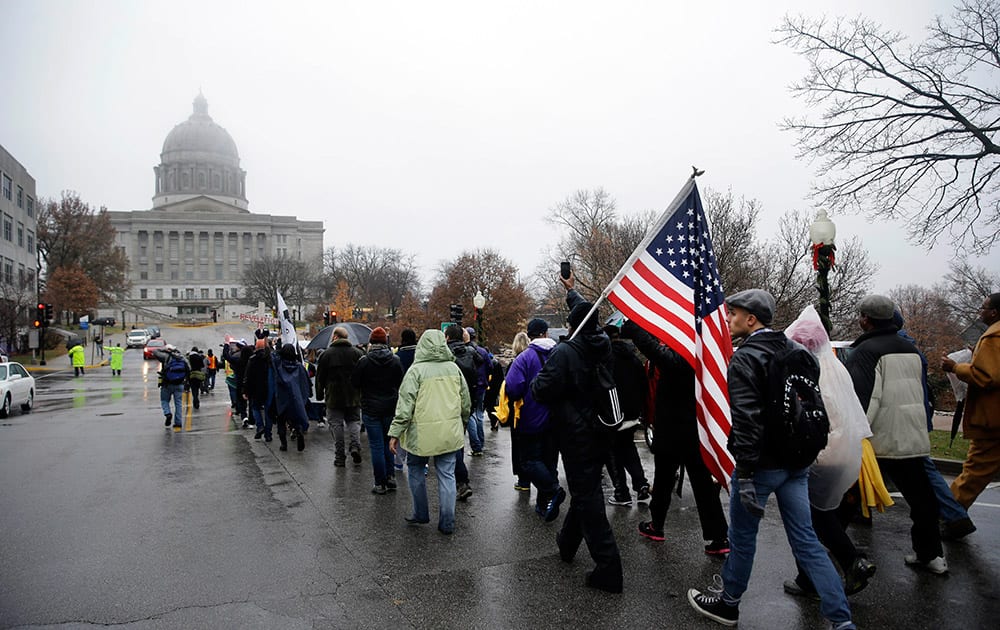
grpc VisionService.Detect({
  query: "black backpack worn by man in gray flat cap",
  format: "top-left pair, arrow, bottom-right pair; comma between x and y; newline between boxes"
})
764,340 -> 830,470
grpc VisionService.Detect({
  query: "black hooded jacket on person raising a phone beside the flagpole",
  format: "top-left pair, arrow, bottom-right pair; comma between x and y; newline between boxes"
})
531,291 -> 614,461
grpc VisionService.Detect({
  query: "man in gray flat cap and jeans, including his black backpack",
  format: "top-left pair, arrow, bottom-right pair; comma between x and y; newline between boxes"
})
688,289 -> 855,630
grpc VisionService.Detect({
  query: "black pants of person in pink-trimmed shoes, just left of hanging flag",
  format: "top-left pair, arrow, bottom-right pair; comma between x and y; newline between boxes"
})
649,432 -> 729,541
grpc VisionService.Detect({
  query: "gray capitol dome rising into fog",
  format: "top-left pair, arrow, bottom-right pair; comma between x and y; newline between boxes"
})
153,92 -> 254,211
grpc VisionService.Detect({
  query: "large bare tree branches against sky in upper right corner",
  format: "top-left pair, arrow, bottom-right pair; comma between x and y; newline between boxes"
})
777,0 -> 1000,253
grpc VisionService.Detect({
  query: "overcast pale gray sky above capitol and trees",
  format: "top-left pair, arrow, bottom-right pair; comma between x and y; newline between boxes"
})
0,0 -> 1000,291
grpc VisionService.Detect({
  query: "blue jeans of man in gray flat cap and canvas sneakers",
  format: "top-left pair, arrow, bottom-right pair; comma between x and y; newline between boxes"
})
722,468 -> 851,626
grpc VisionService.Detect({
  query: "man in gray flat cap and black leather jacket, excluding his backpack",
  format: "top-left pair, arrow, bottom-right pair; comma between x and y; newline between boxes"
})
688,289 -> 855,630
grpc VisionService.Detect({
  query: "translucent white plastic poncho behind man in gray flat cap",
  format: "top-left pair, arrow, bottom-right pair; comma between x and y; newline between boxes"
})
785,306 -> 872,510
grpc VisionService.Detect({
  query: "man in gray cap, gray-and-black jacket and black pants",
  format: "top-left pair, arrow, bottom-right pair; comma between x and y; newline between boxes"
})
845,295 -> 948,575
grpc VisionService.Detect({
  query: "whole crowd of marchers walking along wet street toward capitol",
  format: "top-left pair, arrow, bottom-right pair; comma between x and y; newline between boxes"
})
150,275 -> 1000,629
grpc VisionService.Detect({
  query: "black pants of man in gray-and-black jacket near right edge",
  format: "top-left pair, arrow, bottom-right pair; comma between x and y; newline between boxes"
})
878,457 -> 944,562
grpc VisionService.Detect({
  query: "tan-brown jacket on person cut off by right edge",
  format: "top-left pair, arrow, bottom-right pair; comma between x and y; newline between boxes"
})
955,322 -> 1000,440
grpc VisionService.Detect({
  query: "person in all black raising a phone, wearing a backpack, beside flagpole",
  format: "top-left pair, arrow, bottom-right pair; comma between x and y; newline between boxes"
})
522,273 -> 623,593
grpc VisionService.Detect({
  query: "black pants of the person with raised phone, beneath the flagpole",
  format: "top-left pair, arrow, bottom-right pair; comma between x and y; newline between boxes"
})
559,453 -> 622,589
